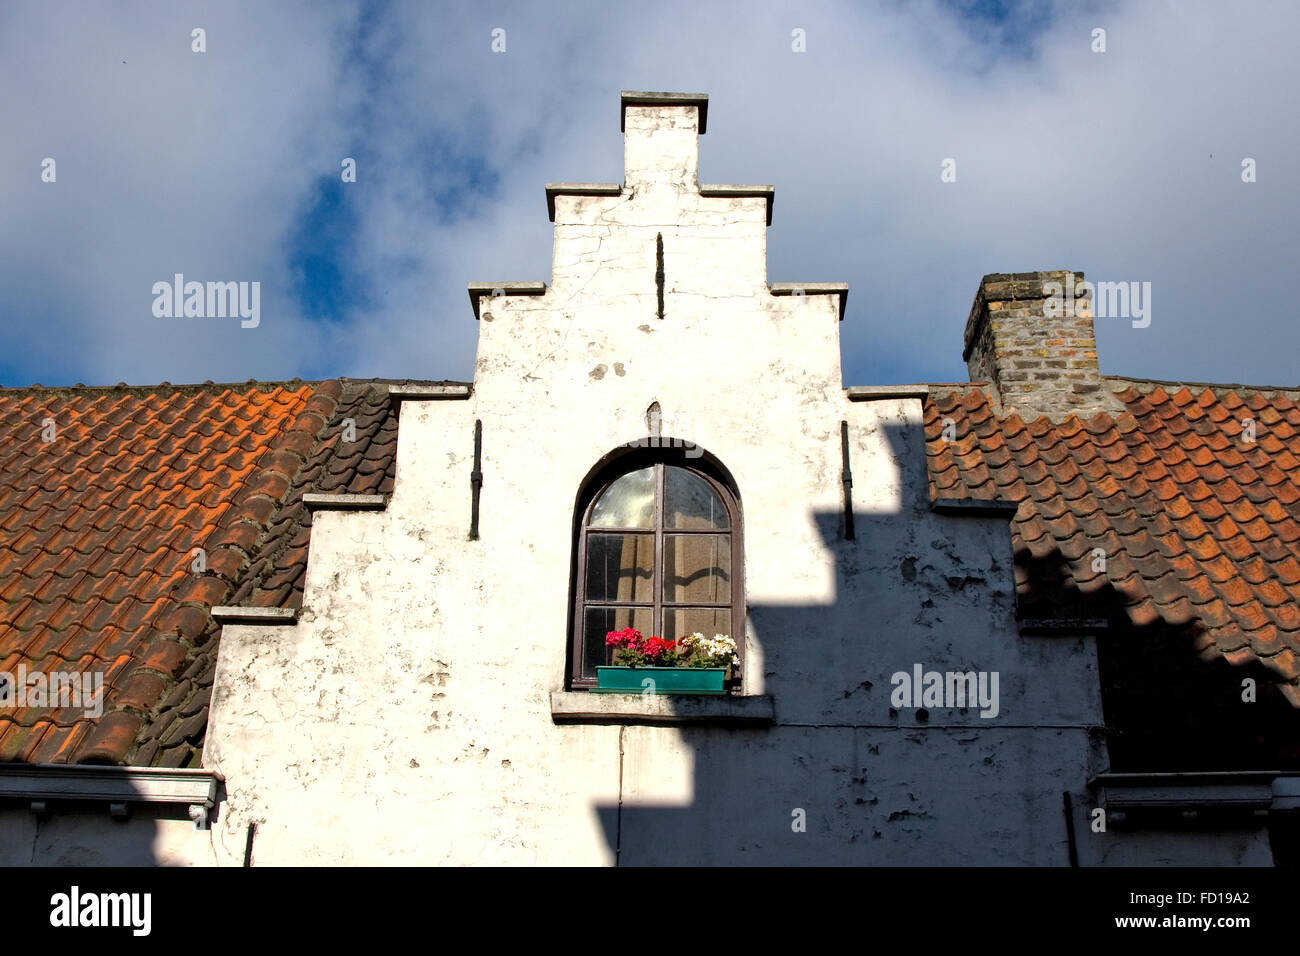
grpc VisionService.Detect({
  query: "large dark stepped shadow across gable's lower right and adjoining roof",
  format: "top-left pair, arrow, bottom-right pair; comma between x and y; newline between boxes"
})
594,425 -> 1300,865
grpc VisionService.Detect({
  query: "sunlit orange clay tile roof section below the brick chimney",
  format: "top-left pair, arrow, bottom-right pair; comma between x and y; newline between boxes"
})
926,380 -> 1300,708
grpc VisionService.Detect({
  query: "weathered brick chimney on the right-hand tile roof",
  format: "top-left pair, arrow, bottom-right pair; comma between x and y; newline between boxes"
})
962,271 -> 1123,421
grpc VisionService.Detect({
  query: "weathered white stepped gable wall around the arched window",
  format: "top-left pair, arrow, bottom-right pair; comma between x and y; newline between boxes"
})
204,98 -> 1274,864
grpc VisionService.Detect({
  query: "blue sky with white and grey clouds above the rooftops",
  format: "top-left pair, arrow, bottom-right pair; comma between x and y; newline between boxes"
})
0,0 -> 1300,385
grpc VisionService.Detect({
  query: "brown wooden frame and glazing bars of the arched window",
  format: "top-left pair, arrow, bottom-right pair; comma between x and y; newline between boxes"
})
567,450 -> 745,695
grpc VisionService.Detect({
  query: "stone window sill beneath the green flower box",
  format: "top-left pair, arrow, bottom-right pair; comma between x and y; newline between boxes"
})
551,691 -> 775,727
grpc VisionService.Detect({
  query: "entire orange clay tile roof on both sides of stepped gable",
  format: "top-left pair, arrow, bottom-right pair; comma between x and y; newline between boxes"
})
0,369 -> 1300,767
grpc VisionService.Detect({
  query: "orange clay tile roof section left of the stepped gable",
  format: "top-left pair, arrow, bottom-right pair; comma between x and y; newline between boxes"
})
0,380 -> 462,767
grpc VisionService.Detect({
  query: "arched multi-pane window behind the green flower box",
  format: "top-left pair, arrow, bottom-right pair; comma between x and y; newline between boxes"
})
569,454 -> 745,689
